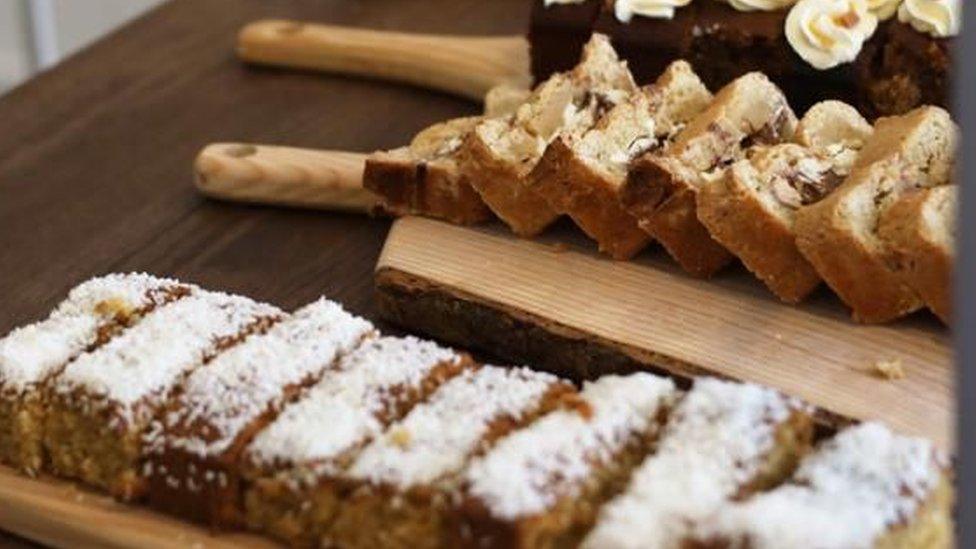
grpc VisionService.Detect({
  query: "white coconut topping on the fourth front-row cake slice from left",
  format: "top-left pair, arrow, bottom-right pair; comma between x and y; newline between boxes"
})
247,337 -> 461,466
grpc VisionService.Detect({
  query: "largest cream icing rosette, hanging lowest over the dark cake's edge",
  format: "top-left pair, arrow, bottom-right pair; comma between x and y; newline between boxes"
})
786,0 -> 878,70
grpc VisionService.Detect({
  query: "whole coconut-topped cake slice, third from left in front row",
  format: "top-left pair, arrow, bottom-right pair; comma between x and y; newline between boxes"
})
143,299 -> 374,528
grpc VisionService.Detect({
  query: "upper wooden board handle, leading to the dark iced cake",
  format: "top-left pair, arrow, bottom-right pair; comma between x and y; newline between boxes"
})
237,20 -> 532,101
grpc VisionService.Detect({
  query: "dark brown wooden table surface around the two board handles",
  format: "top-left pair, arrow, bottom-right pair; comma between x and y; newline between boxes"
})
0,0 -> 528,547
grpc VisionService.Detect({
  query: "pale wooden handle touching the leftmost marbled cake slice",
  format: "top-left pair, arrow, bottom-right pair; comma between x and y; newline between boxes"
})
194,143 -> 376,212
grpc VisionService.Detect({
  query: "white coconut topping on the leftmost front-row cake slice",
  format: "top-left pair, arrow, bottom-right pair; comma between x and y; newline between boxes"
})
0,274 -> 184,393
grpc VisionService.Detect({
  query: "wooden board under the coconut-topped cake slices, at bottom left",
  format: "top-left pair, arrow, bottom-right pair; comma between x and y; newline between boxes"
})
0,466 -> 277,549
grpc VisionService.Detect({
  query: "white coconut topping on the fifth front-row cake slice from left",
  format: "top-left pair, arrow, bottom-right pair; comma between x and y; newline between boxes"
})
348,366 -> 558,488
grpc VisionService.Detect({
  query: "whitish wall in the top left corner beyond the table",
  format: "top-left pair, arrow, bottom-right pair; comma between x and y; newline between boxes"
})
0,0 -> 162,93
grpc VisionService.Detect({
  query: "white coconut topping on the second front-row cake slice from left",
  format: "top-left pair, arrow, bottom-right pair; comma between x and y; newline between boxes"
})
54,291 -> 282,420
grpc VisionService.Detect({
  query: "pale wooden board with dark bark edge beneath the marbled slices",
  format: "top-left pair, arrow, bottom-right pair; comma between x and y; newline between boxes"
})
376,218 -> 954,450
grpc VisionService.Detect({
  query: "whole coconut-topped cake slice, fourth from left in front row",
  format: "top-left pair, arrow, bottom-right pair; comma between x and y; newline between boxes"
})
242,337 -> 474,546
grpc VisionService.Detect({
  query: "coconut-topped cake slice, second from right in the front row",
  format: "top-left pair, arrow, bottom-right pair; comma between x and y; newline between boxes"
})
582,378 -> 813,549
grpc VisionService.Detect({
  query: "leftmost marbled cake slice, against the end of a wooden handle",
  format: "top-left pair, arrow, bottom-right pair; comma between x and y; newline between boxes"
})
363,116 -> 491,225
